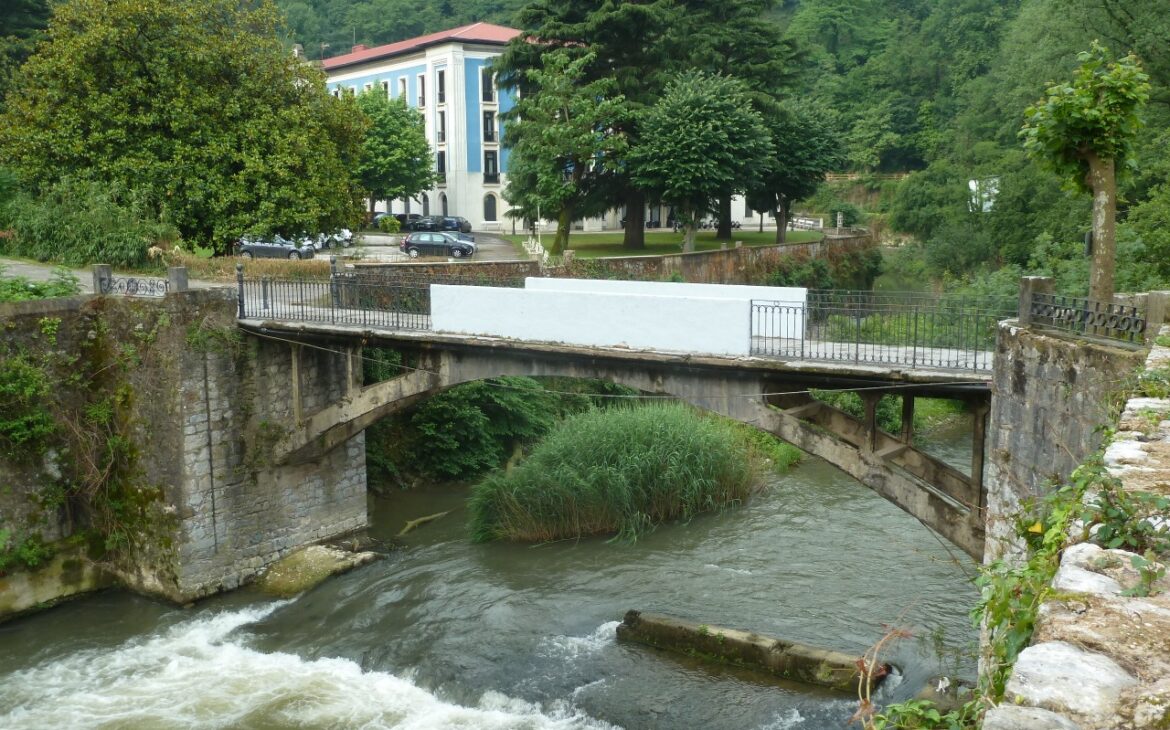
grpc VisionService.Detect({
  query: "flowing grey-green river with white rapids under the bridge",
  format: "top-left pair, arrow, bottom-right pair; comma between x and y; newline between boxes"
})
0,425 -> 976,730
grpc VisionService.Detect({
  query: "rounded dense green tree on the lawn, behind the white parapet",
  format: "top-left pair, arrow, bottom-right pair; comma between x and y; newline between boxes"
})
627,71 -> 772,252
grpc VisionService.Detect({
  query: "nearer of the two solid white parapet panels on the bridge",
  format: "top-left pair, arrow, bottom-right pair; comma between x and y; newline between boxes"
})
431,284 -> 751,357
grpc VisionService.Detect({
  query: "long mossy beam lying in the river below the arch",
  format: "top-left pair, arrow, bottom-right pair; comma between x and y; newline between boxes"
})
618,611 -> 889,691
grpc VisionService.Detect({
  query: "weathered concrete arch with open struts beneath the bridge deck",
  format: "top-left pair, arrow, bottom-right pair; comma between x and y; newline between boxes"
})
263,332 -> 990,559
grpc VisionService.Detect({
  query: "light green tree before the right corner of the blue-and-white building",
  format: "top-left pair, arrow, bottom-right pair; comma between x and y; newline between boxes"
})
504,49 -> 628,254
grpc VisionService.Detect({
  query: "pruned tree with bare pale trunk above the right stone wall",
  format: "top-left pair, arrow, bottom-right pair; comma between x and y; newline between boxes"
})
1020,42 -> 1150,302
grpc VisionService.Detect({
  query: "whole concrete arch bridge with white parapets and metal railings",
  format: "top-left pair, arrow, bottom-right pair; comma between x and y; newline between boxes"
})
238,277 -> 996,559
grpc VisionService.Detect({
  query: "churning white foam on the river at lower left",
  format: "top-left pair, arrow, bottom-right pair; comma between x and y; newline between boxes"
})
0,604 -> 613,730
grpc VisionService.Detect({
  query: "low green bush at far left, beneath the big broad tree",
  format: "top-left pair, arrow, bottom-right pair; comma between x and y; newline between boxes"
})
0,178 -> 178,267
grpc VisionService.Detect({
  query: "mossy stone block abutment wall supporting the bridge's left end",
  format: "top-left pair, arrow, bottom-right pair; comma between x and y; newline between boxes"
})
0,290 -> 366,620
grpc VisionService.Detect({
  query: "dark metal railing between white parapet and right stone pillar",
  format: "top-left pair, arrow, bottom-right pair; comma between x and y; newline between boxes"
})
751,290 -> 1017,371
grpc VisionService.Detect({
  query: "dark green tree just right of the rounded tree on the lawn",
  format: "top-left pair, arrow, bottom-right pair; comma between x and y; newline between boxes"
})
748,104 -> 845,243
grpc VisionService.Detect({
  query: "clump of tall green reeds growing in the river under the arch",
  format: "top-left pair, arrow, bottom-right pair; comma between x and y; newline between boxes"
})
469,402 -> 786,542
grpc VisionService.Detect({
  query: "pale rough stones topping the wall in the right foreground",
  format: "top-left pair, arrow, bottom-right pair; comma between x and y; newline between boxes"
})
983,326 -> 1170,730
